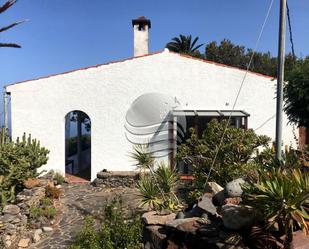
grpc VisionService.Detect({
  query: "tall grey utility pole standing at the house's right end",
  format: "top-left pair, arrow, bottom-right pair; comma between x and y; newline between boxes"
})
276,0 -> 286,160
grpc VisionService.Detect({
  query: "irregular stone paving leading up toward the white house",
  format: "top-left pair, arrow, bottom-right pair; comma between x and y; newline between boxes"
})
30,184 -> 139,249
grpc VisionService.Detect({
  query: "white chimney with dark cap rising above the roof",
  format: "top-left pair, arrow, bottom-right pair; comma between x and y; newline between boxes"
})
132,16 -> 151,57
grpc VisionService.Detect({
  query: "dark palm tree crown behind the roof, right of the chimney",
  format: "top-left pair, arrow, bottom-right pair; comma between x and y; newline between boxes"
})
166,35 -> 204,55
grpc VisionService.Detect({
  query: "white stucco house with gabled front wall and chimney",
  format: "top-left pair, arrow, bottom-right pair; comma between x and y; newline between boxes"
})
6,18 -> 295,180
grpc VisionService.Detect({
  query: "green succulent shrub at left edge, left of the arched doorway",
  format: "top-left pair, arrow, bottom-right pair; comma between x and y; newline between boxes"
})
0,129 -> 49,205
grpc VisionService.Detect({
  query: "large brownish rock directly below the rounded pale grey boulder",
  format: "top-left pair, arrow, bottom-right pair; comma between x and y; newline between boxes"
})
221,204 -> 256,230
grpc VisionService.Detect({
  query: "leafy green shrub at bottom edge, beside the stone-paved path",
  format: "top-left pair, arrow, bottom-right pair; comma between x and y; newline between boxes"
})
69,198 -> 142,249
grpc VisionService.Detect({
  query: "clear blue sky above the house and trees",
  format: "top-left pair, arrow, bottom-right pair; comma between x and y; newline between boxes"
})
0,0 -> 309,88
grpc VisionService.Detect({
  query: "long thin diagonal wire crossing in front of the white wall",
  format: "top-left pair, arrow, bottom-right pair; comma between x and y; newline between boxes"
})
204,0 -> 274,187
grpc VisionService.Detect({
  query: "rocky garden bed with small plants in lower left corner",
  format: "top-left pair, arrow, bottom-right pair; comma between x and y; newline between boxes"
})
0,173 -> 61,248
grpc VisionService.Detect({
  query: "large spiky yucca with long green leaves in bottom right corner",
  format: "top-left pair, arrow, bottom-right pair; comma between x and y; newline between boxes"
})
242,168 -> 309,248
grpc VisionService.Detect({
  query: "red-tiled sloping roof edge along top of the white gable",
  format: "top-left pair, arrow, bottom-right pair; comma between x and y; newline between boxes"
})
5,51 -> 275,87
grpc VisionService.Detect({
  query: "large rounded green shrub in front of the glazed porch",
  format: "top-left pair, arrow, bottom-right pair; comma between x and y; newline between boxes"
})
176,119 -> 270,200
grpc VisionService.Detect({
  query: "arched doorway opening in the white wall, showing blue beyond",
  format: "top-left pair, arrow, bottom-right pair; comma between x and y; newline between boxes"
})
65,110 -> 91,181
